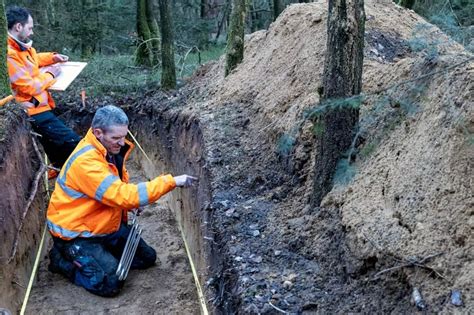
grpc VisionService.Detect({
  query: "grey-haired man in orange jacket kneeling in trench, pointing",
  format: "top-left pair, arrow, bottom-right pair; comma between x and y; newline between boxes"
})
47,105 -> 197,296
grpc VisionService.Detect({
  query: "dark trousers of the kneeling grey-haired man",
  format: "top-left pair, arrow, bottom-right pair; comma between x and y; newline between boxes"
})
50,224 -> 156,297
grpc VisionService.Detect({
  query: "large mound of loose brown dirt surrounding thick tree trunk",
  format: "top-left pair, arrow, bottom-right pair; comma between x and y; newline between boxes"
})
180,2 -> 474,312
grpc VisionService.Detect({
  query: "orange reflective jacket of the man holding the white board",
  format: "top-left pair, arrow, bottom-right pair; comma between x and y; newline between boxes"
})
7,36 -> 56,116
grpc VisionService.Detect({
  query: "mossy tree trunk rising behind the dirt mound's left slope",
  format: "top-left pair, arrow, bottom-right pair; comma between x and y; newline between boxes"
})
225,0 -> 245,76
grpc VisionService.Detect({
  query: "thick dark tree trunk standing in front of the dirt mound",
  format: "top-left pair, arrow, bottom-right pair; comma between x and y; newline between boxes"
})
313,0 -> 365,205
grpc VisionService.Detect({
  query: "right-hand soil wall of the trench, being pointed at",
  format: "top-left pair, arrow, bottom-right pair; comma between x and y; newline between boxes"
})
128,110 -> 215,311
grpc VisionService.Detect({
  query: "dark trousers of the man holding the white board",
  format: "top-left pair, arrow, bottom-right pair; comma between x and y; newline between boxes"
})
31,111 -> 81,168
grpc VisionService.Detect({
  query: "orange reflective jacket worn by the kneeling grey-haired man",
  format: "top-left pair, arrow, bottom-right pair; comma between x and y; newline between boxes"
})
47,129 -> 176,240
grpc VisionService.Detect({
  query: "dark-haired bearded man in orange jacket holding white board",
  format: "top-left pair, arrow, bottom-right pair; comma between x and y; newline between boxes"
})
6,6 -> 81,177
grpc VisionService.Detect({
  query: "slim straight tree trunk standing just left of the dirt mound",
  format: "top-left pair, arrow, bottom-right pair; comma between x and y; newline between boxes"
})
158,0 -> 176,89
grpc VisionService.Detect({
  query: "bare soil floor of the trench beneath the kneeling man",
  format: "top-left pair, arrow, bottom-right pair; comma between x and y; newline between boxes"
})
26,162 -> 199,314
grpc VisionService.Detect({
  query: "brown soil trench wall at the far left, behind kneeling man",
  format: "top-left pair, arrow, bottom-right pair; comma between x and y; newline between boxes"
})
0,105 -> 46,313
